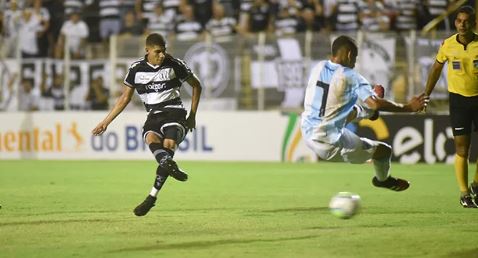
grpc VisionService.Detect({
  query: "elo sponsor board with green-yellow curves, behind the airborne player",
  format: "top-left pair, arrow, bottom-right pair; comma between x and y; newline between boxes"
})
281,114 -> 478,164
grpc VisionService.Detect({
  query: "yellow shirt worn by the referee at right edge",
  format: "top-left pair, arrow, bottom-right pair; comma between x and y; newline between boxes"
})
436,34 -> 478,97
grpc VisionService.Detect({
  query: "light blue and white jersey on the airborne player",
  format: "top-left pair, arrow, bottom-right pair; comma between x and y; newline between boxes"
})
301,60 -> 374,144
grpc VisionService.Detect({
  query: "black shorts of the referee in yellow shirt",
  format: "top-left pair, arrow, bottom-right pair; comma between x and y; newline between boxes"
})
449,92 -> 478,136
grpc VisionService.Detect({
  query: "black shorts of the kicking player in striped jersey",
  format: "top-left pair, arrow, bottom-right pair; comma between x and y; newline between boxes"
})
143,108 -> 188,144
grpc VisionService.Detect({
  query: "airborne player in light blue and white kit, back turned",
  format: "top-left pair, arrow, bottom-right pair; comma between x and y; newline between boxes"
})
301,36 -> 428,191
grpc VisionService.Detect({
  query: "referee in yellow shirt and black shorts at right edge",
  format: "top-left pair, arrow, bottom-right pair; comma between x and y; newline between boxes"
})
425,6 -> 478,208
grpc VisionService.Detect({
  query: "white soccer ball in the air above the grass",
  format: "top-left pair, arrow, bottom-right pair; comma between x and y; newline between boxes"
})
329,192 -> 360,219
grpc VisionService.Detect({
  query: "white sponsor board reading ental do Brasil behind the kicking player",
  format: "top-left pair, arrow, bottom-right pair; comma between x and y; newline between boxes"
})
0,112 -> 288,161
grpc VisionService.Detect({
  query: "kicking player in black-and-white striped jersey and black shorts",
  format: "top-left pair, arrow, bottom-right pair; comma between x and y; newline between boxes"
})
92,33 -> 202,216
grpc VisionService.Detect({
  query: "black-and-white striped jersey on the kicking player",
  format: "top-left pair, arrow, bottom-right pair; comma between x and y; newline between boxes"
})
124,54 -> 193,113
